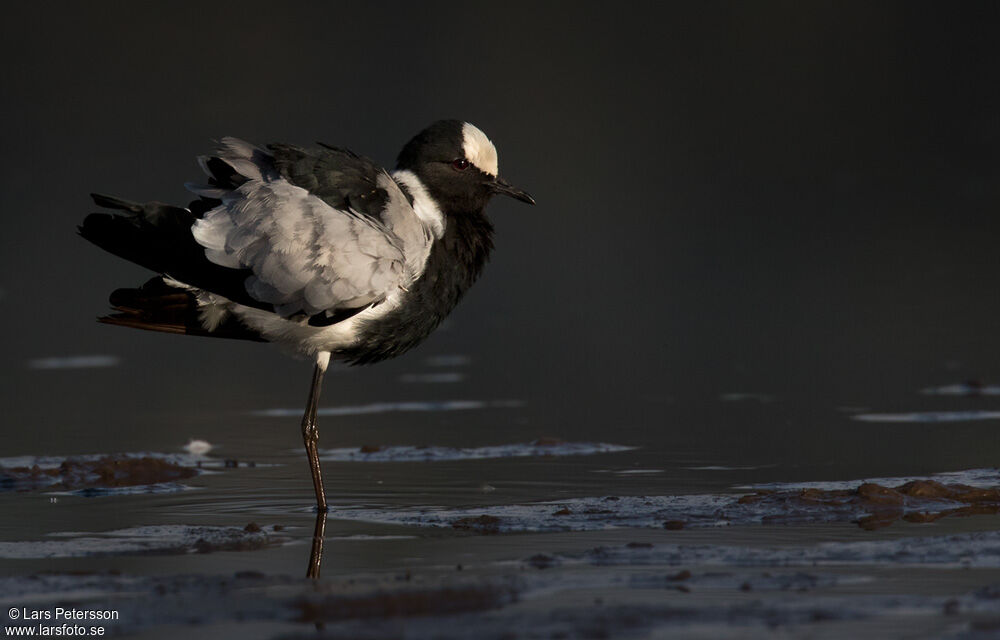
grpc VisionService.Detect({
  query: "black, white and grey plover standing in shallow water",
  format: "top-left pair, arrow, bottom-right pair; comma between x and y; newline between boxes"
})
78,120 -> 535,513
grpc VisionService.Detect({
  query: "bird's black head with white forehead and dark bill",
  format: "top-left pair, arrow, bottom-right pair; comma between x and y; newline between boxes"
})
396,120 -> 535,213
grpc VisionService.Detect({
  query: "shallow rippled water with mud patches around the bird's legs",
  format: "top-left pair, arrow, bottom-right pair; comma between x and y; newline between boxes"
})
0,376 -> 1000,638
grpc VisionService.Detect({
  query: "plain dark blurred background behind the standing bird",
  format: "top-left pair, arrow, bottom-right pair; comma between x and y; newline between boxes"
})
0,2 -> 1000,479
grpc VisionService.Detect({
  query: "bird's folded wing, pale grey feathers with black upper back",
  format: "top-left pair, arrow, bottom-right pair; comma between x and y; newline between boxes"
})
191,138 -> 432,325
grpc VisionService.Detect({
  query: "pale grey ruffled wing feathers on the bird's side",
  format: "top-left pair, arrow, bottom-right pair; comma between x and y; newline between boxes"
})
192,138 -> 430,317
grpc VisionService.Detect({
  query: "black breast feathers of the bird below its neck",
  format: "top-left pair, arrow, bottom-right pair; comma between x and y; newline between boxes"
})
333,212 -> 493,364
